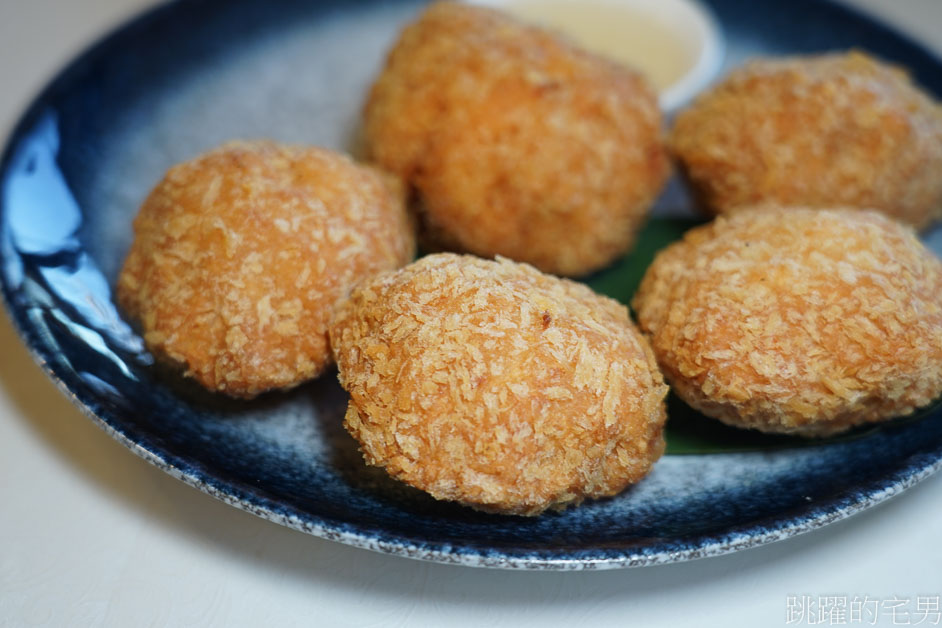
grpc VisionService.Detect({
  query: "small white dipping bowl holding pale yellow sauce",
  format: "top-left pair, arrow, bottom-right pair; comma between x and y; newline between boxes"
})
468,0 -> 724,113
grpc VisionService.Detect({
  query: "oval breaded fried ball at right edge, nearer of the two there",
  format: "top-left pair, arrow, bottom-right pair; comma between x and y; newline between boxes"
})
632,207 -> 942,436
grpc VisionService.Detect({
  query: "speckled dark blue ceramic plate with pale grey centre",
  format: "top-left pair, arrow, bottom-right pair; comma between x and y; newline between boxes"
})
0,0 -> 942,569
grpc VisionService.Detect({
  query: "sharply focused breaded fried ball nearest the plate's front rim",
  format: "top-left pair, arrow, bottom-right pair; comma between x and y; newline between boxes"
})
330,253 -> 667,515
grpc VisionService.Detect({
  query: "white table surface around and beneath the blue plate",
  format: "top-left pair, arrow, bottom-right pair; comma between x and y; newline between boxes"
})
0,0 -> 942,627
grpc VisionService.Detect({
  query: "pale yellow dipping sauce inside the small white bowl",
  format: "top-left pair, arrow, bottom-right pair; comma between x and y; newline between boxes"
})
501,0 -> 696,91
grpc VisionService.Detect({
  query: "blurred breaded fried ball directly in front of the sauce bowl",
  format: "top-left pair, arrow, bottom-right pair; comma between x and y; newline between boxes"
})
364,2 -> 669,275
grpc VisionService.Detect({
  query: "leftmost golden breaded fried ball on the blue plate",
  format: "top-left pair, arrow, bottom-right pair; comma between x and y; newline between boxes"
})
117,142 -> 415,397
